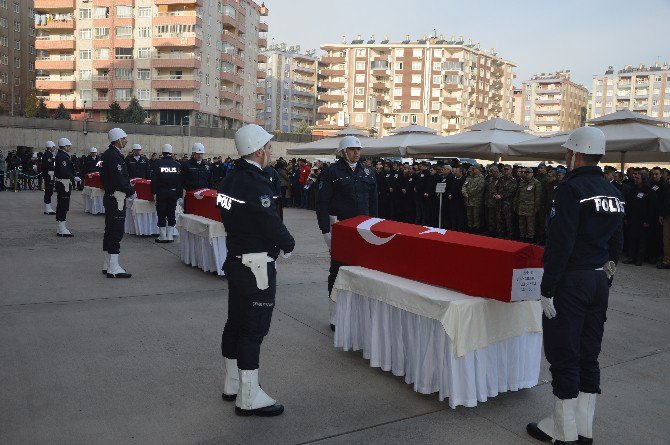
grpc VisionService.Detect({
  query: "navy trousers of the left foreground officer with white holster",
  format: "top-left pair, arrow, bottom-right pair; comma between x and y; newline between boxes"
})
221,256 -> 277,370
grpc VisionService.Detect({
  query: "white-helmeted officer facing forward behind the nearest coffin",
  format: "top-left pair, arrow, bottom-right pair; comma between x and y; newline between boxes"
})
316,136 -> 378,331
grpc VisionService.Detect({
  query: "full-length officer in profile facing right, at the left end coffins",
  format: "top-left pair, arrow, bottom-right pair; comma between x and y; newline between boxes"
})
100,128 -> 136,278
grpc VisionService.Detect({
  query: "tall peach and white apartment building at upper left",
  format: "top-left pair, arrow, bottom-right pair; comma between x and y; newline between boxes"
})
35,0 -> 268,128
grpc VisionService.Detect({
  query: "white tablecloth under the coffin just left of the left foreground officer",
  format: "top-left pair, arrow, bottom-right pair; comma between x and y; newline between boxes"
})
177,214 -> 228,276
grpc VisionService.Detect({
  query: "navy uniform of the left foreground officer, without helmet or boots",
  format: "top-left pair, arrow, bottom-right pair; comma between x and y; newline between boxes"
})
217,159 -> 295,370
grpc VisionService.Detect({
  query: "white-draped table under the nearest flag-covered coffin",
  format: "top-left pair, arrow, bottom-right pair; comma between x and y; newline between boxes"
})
331,266 -> 542,408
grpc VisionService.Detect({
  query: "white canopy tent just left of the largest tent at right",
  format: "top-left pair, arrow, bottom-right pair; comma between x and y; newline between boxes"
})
407,118 -> 535,161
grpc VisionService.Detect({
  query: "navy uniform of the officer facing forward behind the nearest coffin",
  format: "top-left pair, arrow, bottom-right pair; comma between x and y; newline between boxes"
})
316,158 -> 378,295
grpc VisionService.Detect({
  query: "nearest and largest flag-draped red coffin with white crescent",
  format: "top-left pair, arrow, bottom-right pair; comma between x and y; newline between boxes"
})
332,216 -> 544,302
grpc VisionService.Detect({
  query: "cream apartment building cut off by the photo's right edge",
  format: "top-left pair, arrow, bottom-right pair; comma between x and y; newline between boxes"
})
591,62 -> 670,120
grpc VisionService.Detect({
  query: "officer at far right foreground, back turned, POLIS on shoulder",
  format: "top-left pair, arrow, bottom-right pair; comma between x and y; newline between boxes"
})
526,127 -> 624,444
